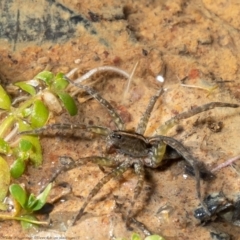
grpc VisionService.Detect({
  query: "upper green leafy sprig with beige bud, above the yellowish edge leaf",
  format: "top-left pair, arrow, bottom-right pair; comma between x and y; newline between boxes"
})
0,71 -> 77,178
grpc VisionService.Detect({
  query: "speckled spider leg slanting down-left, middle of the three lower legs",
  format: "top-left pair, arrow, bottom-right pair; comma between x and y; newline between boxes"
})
72,160 -> 132,225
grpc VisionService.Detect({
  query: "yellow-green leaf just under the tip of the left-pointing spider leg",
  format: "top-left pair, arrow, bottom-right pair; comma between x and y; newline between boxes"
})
22,135 -> 42,167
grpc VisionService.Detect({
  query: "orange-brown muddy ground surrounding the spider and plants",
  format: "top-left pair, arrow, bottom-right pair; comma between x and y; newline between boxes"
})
0,0 -> 240,240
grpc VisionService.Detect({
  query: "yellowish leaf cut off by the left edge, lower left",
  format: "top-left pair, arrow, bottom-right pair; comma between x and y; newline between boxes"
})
0,157 -> 10,209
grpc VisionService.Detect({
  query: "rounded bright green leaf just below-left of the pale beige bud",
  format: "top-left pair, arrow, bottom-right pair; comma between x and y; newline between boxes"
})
31,100 -> 49,128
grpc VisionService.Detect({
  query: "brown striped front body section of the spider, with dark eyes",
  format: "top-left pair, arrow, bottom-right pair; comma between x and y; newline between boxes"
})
107,131 -> 152,157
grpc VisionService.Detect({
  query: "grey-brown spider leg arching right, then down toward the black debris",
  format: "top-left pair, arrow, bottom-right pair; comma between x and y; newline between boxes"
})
149,135 -> 210,214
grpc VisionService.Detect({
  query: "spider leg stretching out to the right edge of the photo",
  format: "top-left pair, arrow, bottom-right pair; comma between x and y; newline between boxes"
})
154,102 -> 240,135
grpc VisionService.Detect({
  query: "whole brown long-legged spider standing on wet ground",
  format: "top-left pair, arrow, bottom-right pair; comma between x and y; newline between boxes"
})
23,73 -> 239,229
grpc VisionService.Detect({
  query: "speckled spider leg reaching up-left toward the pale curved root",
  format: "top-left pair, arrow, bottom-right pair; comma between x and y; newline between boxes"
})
65,76 -> 124,130
